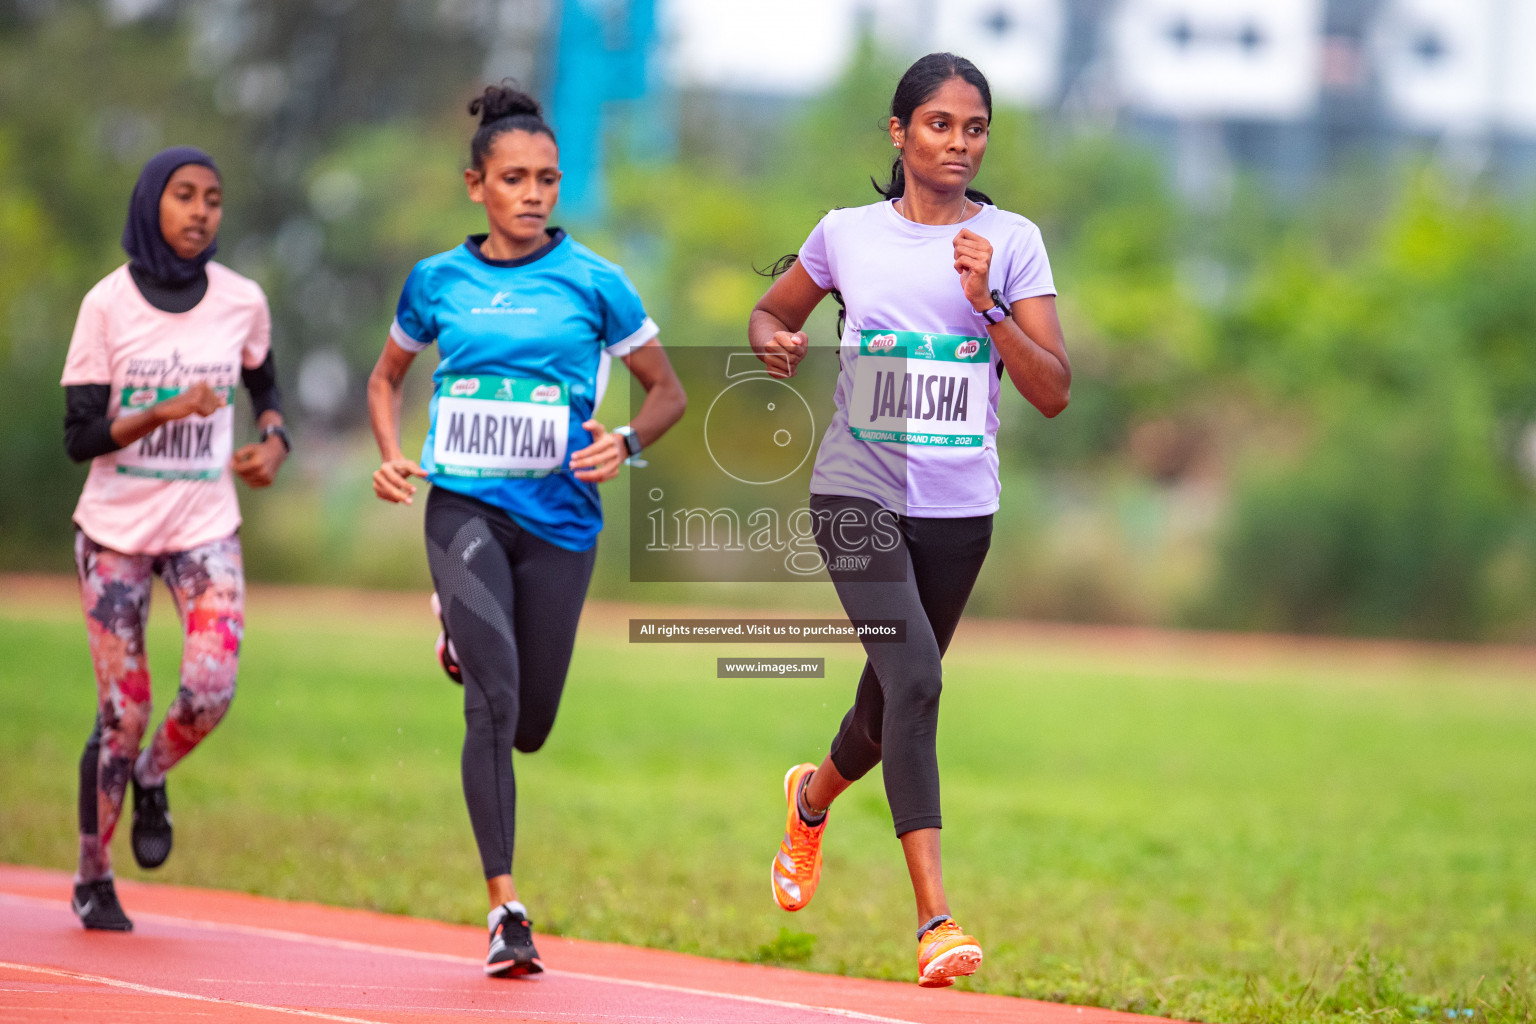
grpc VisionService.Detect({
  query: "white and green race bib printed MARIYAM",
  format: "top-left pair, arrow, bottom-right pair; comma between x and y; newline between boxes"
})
432,376 -> 570,477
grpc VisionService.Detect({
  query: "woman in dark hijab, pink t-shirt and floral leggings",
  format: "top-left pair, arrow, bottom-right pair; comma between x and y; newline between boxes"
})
61,146 -> 289,932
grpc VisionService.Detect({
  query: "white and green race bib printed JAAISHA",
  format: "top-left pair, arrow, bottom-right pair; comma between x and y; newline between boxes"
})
848,330 -> 992,448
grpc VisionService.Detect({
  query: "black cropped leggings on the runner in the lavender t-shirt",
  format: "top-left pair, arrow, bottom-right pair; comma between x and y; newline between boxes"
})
811,494 -> 992,835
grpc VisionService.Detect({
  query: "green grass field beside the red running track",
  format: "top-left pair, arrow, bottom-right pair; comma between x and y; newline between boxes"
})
0,586 -> 1536,1024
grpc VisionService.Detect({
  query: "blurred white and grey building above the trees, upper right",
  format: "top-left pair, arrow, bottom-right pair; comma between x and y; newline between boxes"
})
662,0 -> 1536,197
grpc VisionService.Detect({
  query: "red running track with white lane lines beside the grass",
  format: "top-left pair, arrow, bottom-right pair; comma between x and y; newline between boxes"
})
0,864 -> 1185,1024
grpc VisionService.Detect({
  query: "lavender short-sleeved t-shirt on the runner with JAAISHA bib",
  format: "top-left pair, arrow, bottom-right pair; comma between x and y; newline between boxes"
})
800,201 -> 1055,519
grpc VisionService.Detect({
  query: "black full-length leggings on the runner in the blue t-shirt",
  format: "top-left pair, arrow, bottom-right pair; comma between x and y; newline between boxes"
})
427,487 -> 598,878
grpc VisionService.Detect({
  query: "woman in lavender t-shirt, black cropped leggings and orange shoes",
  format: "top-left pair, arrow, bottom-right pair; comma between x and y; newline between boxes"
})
748,54 -> 1072,987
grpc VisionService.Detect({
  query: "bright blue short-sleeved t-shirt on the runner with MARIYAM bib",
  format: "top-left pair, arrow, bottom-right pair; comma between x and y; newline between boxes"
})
390,227 -> 659,551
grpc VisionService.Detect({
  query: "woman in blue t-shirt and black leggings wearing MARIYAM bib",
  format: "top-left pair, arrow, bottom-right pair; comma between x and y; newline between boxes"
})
369,84 -> 687,976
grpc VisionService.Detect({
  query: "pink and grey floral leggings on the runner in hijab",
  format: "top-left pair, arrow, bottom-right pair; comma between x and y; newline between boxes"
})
75,531 -> 246,881
